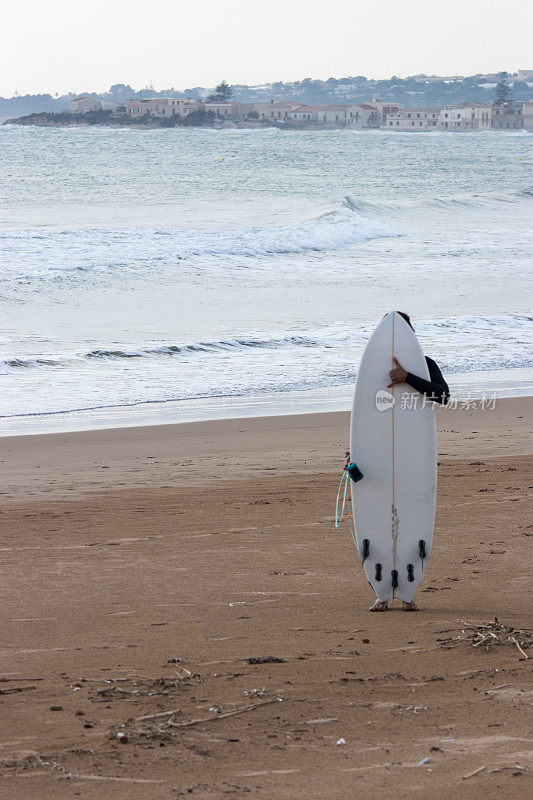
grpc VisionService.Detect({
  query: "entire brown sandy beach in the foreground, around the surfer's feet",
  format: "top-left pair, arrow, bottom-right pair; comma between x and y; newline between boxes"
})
0,397 -> 533,800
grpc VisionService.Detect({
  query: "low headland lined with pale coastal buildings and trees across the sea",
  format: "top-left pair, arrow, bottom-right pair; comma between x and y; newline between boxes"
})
6,73 -> 533,133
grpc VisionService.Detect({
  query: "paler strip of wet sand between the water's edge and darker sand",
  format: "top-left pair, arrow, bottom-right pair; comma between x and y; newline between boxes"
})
0,397 -> 533,504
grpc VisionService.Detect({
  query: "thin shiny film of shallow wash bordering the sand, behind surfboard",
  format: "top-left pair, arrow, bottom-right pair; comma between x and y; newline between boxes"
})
0,367 -> 533,439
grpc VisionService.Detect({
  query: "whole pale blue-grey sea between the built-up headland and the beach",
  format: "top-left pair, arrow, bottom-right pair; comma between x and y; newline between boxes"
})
0,126 -> 532,425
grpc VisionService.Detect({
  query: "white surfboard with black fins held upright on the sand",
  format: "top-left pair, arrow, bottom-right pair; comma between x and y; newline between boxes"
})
350,311 -> 437,602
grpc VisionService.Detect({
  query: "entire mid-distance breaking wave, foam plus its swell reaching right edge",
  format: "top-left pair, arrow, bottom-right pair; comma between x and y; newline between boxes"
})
0,188 -> 533,284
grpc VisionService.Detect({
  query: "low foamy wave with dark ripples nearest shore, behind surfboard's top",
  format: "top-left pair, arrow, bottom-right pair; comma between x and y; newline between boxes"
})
0,314 -> 533,417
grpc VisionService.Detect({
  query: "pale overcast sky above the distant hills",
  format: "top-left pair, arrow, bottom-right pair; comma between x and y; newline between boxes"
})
0,0 -> 533,96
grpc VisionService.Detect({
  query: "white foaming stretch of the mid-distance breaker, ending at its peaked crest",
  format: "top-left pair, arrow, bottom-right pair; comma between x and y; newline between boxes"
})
0,203 -> 401,282
